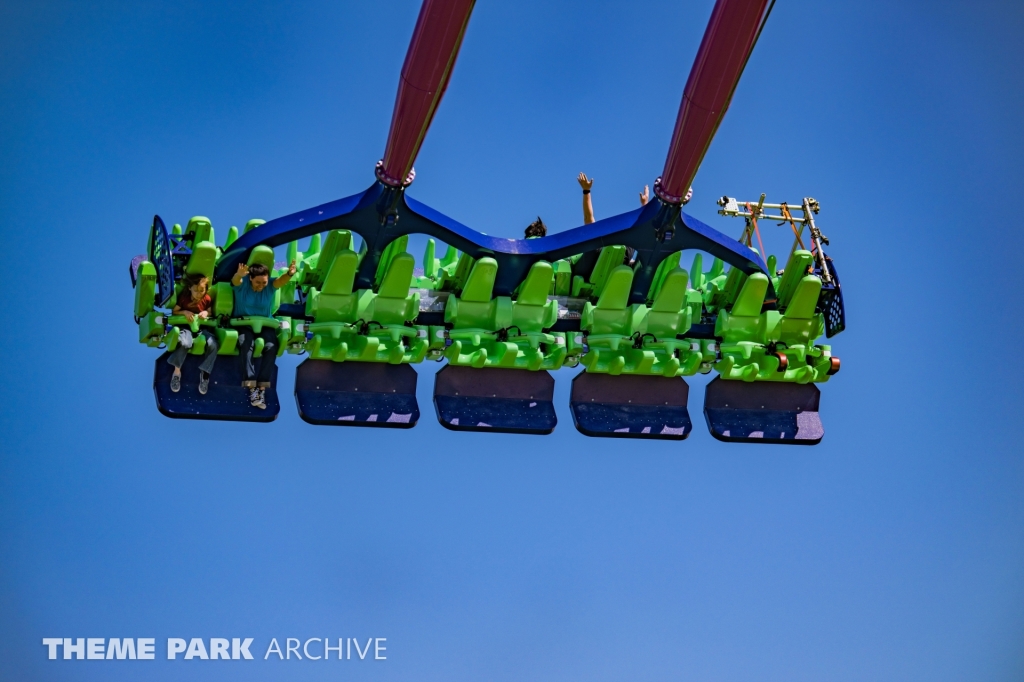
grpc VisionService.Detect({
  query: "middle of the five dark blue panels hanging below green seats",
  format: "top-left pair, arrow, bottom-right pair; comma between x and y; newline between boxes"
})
434,365 -> 558,434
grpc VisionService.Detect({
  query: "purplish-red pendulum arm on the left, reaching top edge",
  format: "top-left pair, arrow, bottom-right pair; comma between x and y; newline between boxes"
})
377,0 -> 475,187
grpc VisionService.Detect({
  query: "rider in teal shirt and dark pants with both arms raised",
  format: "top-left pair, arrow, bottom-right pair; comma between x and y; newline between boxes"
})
231,260 -> 295,410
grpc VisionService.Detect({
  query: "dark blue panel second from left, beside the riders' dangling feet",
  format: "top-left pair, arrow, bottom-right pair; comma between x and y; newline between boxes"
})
295,359 -> 420,429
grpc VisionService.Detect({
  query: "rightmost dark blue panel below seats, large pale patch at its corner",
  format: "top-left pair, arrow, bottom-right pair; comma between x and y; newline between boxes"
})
705,377 -> 824,445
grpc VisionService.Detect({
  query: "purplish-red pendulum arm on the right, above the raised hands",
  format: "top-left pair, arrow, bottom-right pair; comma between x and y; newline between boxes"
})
654,0 -> 768,205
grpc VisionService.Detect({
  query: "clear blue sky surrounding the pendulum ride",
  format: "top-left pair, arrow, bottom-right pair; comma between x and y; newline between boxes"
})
0,0 -> 1024,682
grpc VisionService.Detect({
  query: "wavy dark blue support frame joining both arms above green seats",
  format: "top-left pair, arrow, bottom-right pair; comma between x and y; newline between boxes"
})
215,182 -> 775,303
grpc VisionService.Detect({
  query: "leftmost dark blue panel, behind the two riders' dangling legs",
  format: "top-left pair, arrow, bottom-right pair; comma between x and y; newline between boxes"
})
153,353 -> 281,422
